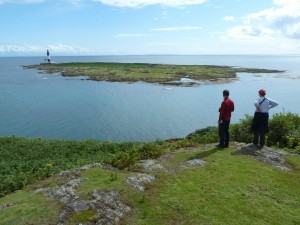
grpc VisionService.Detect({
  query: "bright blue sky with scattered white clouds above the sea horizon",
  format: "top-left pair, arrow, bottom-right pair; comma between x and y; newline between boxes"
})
0,0 -> 300,56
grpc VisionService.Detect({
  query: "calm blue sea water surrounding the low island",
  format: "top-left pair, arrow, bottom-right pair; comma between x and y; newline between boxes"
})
0,55 -> 300,141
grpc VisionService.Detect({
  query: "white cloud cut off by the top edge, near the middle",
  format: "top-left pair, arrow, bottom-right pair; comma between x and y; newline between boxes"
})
94,0 -> 207,8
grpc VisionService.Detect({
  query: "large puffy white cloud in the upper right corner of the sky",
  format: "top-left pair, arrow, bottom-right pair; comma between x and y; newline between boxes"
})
228,0 -> 300,39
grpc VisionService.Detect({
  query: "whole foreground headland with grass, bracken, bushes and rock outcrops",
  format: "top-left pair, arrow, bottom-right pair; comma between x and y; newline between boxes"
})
0,113 -> 300,225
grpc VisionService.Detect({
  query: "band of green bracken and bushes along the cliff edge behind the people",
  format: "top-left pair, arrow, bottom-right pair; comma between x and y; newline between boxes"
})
0,113 -> 300,197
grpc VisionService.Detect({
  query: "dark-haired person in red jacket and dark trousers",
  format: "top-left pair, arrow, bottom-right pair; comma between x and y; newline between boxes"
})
217,90 -> 234,148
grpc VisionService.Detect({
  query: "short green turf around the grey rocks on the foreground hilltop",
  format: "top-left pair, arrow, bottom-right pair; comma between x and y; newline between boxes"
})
0,147 -> 300,225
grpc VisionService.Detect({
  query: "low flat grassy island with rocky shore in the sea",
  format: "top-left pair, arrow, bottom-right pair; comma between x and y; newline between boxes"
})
24,62 -> 283,86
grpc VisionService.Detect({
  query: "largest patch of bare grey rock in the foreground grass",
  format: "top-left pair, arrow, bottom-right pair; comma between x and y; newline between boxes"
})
35,163 -> 129,225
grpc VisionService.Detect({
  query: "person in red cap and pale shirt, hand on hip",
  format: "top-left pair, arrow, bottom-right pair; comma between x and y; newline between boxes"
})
251,89 -> 278,149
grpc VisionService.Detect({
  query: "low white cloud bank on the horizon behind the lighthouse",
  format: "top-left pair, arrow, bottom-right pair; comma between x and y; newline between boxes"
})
0,44 -> 89,54
